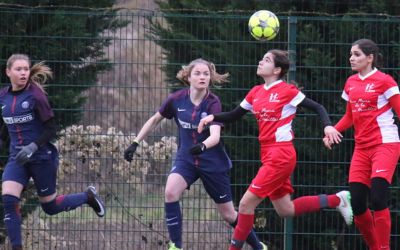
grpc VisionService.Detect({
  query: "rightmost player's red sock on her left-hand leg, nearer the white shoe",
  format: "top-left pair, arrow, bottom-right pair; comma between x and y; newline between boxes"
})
354,209 -> 378,250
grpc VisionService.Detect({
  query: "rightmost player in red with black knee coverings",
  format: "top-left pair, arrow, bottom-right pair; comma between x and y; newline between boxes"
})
324,39 -> 400,250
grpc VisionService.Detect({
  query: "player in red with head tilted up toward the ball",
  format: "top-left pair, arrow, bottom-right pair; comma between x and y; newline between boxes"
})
198,50 -> 352,250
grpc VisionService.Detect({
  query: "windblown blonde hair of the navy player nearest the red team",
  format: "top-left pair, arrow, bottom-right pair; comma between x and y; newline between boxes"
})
176,58 -> 229,85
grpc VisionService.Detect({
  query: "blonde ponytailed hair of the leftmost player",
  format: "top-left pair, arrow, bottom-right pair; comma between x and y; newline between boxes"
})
7,54 -> 53,93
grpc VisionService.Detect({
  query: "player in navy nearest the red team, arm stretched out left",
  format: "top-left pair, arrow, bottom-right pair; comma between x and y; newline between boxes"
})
124,59 -> 267,250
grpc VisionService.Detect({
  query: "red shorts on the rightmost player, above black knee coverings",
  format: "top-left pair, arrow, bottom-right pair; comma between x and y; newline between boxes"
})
349,143 -> 400,187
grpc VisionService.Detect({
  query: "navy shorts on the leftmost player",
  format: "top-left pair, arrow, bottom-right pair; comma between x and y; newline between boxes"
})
2,145 -> 58,197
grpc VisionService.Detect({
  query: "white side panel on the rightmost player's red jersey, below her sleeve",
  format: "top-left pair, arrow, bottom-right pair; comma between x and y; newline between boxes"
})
376,109 -> 400,143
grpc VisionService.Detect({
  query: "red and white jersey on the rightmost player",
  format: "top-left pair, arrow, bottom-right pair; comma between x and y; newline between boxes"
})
342,69 -> 399,147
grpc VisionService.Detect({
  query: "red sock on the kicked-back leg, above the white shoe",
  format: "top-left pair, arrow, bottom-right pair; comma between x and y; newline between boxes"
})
293,194 -> 340,216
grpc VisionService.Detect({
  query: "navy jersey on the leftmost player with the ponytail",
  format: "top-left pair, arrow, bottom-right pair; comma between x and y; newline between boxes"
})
0,83 -> 54,156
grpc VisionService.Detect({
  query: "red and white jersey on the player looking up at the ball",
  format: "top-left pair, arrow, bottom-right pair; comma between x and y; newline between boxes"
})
240,80 -> 305,144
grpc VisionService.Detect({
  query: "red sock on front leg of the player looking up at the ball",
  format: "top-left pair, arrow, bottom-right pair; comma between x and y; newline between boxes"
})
229,213 -> 254,250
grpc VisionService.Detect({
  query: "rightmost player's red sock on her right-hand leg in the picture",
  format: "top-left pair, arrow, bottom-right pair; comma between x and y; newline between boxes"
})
374,208 -> 392,249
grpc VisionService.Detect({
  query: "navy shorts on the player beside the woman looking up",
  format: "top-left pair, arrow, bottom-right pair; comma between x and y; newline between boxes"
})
170,162 -> 232,204
